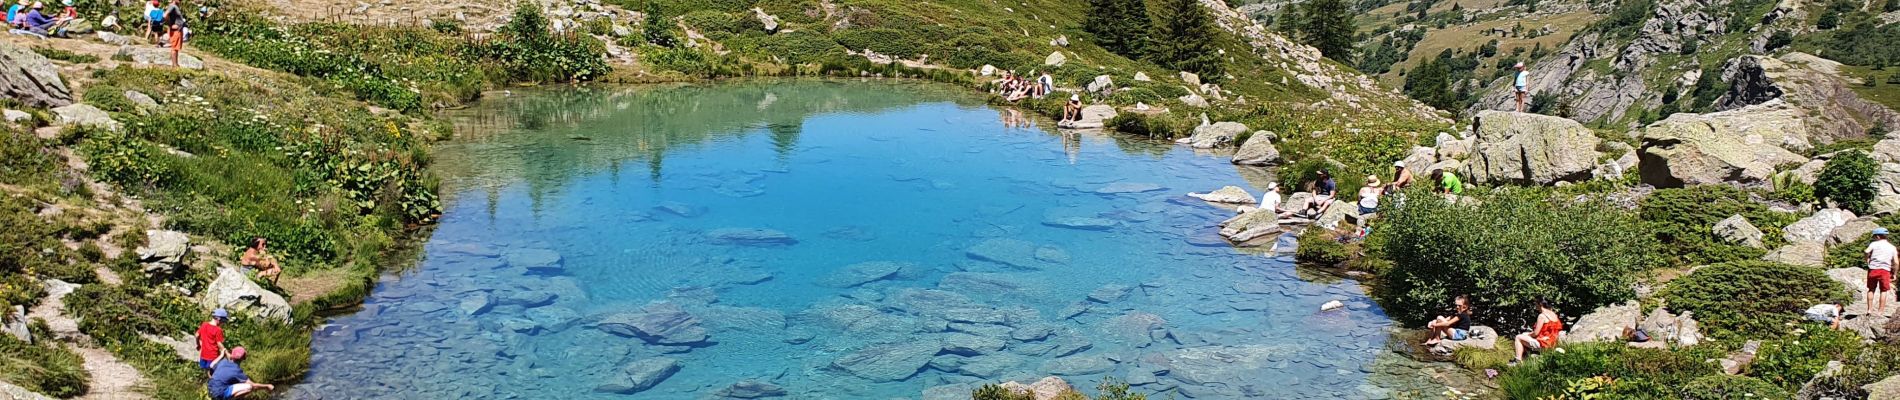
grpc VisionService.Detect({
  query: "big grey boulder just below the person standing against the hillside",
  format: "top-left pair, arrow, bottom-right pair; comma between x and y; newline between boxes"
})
1469,110 -> 1602,184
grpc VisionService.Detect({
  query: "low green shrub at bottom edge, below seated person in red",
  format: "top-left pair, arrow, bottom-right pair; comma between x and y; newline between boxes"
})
1497,343 -> 1721,398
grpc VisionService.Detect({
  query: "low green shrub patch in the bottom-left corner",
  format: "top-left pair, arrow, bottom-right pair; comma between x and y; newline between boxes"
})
0,336 -> 91,398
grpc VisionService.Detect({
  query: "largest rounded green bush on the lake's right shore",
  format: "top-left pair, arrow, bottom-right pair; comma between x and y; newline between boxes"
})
1368,186 -> 1657,326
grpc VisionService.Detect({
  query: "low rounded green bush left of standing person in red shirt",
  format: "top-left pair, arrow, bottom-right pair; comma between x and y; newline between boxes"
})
1663,260 -> 1847,339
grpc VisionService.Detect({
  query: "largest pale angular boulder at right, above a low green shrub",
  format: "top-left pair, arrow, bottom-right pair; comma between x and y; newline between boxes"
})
1640,100 -> 1813,188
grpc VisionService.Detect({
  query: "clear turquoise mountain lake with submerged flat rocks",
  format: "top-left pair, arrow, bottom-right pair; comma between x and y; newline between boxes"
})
293,82 -> 1389,398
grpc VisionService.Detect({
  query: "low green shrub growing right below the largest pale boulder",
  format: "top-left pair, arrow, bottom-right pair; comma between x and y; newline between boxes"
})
1638,184 -> 1796,265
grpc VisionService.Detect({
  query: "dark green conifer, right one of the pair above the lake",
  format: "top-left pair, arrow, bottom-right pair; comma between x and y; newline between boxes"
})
1148,0 -> 1223,82
